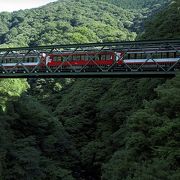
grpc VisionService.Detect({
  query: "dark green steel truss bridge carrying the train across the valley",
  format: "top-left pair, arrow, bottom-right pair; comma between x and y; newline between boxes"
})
0,40 -> 180,78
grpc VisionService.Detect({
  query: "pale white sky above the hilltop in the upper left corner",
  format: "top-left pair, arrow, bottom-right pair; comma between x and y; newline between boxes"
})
0,0 -> 56,12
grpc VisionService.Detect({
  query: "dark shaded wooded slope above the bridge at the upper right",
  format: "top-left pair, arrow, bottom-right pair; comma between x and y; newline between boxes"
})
141,0 -> 180,40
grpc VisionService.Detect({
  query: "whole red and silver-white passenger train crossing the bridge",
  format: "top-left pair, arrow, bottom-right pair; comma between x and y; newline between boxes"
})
0,49 -> 180,70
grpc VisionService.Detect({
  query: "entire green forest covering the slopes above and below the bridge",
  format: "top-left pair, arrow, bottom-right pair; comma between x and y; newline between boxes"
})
0,0 -> 180,180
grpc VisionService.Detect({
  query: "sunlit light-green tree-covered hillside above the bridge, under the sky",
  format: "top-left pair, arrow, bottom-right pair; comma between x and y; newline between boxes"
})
0,0 -> 140,46
